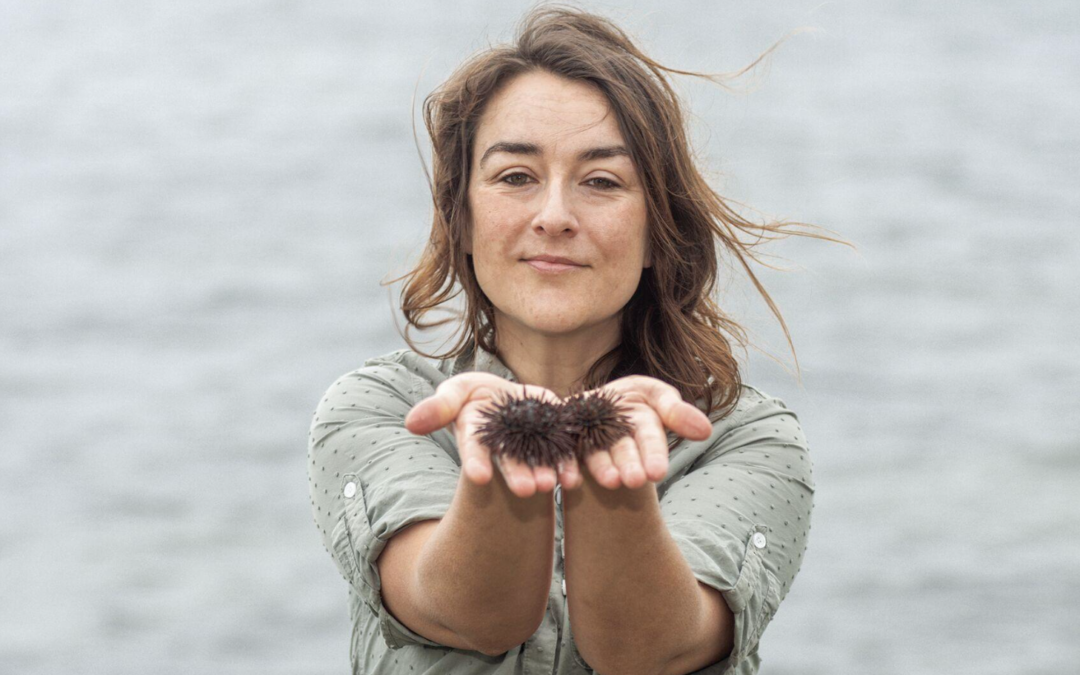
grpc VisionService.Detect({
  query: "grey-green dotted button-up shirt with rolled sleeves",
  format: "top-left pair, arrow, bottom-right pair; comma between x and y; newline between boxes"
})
308,349 -> 814,675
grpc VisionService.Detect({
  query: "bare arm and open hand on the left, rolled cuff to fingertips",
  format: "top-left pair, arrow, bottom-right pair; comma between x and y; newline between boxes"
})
395,373 -> 555,656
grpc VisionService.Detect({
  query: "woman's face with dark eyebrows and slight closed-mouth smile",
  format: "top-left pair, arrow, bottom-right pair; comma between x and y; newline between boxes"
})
467,72 -> 651,336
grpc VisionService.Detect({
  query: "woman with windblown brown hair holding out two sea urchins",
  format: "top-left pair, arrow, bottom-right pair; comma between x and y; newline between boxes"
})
309,8 -> 836,675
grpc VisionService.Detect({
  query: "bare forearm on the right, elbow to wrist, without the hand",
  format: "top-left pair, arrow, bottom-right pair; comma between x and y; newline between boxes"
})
564,472 -> 733,675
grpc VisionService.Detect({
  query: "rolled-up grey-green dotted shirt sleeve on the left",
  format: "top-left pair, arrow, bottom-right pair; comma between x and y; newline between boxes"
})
308,360 -> 460,649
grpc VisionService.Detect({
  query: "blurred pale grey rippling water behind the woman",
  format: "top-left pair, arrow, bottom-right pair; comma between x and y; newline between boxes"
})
0,0 -> 1080,675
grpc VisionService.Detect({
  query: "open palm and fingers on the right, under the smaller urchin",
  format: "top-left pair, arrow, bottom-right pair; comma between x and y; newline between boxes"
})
559,375 -> 713,489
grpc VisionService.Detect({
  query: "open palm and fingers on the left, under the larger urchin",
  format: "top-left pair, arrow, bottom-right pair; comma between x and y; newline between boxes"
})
405,372 -> 581,497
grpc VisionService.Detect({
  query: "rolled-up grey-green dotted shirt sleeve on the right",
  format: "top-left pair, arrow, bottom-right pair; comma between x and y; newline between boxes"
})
660,387 -> 814,675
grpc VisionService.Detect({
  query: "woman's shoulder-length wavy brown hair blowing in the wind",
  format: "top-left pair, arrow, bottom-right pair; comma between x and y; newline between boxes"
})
383,5 -> 850,416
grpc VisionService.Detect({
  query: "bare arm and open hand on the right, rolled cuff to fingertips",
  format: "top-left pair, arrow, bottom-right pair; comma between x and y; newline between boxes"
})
564,376 -> 734,675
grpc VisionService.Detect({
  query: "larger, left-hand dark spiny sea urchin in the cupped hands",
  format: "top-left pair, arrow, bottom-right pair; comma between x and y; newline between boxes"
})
477,388 -> 575,468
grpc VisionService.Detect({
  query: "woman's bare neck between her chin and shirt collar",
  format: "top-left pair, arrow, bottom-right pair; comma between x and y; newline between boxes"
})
496,315 -> 620,396
